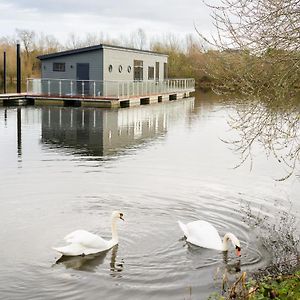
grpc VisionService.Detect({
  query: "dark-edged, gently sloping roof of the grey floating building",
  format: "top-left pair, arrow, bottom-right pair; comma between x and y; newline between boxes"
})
37,44 -> 168,60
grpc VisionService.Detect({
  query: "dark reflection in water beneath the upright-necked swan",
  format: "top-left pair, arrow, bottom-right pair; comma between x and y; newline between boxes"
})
55,245 -> 124,277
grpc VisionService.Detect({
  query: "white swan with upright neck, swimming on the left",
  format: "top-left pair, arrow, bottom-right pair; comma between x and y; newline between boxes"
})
52,211 -> 124,256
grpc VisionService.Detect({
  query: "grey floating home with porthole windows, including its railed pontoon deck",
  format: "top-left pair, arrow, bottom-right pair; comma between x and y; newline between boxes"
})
27,44 -> 195,107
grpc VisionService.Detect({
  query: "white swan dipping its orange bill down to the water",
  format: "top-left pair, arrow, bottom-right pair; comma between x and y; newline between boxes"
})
178,220 -> 241,256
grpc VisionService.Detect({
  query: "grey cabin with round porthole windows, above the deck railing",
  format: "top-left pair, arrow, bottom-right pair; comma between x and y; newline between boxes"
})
38,45 -> 168,81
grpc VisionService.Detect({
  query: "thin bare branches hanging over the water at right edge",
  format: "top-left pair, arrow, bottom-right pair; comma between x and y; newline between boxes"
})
223,97 -> 300,181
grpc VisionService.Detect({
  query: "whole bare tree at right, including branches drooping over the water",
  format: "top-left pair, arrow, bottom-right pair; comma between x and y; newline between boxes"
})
198,0 -> 300,179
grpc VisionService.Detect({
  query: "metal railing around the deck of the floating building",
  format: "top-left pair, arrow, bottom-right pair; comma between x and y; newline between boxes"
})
27,78 -> 195,98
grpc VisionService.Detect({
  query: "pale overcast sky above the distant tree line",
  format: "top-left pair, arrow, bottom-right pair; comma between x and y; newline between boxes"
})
0,0 -> 216,41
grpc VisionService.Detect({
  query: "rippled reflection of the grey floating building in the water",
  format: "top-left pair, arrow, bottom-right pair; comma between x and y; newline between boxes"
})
42,98 -> 194,156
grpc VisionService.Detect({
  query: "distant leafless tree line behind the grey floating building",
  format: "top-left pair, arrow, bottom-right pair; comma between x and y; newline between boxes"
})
0,29 -> 211,89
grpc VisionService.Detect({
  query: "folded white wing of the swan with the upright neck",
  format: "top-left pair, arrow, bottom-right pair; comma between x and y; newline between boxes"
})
64,229 -> 107,249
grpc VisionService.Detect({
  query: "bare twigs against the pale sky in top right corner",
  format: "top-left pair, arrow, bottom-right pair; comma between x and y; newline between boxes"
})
200,0 -> 300,52
